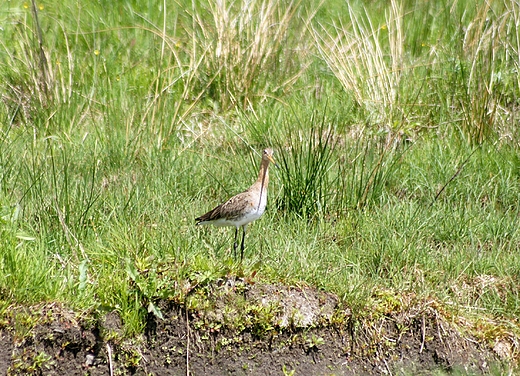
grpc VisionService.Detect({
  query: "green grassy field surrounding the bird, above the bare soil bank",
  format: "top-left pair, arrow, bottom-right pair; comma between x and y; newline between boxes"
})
0,0 -> 520,357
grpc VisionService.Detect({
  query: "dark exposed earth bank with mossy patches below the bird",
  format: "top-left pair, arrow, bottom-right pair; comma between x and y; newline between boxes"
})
0,279 -> 512,375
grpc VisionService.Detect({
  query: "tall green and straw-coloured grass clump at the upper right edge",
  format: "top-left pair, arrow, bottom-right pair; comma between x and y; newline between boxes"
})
460,1 -> 520,144
